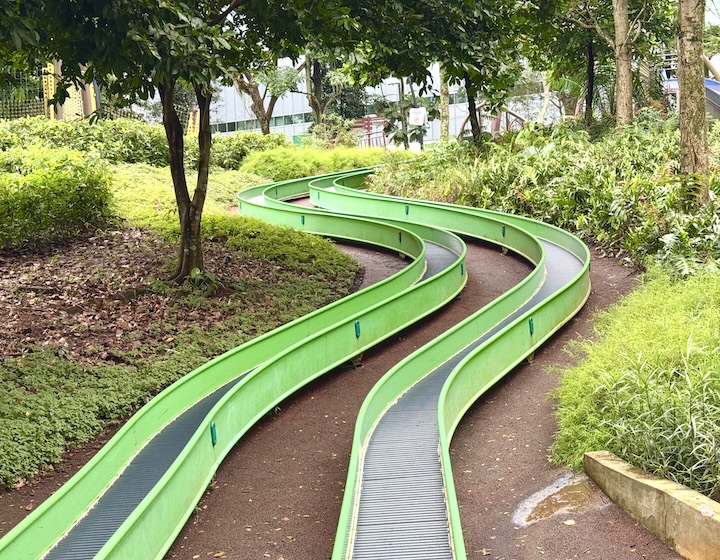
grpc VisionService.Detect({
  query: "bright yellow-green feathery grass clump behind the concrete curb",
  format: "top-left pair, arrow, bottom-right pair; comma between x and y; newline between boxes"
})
552,270 -> 720,499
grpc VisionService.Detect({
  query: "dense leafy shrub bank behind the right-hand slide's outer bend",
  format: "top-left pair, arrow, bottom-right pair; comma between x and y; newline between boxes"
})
373,113 -> 720,275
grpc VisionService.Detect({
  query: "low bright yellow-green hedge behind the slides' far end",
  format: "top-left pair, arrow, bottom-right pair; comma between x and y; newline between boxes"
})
240,147 -> 384,181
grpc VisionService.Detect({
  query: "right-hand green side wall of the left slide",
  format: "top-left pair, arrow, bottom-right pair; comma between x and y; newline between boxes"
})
99,175 -> 466,558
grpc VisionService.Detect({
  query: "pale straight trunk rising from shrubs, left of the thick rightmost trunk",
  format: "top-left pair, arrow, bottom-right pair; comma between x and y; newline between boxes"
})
613,0 -> 633,126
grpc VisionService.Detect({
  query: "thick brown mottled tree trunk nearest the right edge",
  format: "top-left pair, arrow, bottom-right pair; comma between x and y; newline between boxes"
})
678,0 -> 708,199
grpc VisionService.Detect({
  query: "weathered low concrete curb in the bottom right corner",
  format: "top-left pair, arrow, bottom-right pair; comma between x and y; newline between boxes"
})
583,451 -> 720,560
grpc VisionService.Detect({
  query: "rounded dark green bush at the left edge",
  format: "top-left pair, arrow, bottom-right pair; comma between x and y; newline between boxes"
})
0,146 -> 112,249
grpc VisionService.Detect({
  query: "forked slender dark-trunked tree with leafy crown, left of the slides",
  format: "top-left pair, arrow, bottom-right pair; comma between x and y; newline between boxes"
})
33,0 -> 355,282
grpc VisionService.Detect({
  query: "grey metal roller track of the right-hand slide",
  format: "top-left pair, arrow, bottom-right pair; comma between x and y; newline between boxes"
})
350,241 -> 582,560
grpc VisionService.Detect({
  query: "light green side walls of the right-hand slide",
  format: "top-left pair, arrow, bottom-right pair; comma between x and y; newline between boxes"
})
320,183 -> 590,560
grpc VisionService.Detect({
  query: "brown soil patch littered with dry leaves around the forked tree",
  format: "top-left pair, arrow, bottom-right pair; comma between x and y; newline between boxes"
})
0,229 -> 298,362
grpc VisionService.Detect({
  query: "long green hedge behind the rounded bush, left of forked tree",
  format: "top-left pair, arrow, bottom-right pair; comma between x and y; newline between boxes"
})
0,117 -> 168,166
